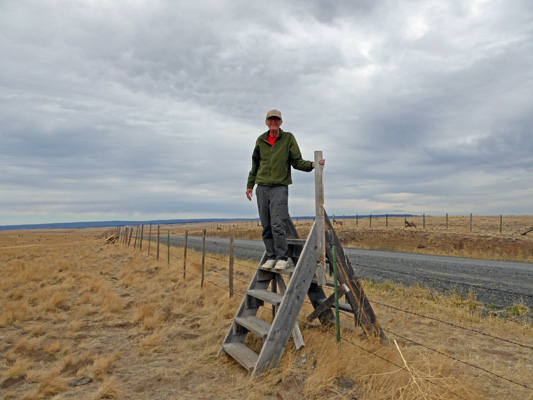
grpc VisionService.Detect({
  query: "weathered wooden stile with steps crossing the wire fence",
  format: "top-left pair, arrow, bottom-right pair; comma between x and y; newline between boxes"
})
218,152 -> 387,378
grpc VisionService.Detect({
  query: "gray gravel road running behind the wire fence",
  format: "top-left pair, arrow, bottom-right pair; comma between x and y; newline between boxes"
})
170,236 -> 533,309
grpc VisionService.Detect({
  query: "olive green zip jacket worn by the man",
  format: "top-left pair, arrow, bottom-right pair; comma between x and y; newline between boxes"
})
246,129 -> 313,189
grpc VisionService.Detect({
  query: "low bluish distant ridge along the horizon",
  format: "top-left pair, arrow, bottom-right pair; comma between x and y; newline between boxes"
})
0,214 -> 414,231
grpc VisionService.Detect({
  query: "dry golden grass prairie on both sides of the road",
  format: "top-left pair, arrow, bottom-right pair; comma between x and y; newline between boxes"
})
0,225 -> 533,400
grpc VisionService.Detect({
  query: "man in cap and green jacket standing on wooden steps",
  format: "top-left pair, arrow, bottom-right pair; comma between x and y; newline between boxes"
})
246,110 -> 325,270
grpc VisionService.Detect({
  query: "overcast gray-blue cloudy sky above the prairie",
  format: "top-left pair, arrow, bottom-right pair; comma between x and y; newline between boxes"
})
0,0 -> 533,225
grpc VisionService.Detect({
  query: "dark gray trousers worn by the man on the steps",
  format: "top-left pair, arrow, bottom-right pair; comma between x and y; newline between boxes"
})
255,185 -> 289,260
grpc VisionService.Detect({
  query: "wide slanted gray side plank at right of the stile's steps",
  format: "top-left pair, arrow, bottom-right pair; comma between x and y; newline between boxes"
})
251,223 -> 317,379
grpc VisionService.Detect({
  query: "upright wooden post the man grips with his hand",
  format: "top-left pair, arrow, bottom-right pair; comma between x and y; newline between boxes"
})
315,151 -> 326,286
